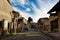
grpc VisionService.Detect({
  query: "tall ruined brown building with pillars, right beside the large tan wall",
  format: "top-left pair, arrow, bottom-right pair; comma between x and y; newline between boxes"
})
9,11 -> 20,33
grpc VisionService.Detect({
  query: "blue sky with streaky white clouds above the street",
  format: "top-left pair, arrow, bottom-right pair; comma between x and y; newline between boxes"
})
10,0 -> 59,22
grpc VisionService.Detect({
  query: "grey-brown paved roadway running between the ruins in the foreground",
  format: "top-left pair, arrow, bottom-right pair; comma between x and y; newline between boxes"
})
1,31 -> 52,40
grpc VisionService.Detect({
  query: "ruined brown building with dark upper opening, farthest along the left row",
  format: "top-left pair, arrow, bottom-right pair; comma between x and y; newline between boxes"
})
18,17 -> 27,32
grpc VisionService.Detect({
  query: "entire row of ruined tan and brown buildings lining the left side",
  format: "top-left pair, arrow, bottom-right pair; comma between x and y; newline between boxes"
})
0,0 -> 27,35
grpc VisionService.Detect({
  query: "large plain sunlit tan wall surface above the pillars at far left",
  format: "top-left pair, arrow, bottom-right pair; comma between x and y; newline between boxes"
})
0,0 -> 13,22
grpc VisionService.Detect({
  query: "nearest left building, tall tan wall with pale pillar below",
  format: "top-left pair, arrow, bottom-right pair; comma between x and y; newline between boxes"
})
0,0 -> 12,33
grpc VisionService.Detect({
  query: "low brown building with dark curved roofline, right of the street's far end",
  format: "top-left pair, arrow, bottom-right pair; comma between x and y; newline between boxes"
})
38,18 -> 50,31
